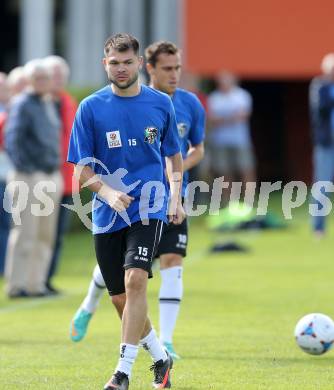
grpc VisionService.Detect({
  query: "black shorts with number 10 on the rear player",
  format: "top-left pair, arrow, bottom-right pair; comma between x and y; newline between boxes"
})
156,218 -> 188,257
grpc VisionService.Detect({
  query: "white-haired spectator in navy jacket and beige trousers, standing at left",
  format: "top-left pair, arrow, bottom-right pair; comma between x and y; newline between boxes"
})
5,59 -> 62,298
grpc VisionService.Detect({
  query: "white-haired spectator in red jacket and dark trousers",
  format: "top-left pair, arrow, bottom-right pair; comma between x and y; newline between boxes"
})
45,56 -> 78,293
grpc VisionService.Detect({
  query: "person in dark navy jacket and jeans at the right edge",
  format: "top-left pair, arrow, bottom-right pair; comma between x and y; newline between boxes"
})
309,53 -> 334,237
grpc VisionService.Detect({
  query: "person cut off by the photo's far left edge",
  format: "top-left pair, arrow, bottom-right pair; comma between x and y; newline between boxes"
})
0,73 -> 10,275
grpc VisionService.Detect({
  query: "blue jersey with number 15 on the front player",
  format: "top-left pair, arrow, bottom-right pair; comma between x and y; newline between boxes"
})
68,85 -> 180,234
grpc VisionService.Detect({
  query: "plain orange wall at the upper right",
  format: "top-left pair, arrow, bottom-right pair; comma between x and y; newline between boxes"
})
184,0 -> 334,79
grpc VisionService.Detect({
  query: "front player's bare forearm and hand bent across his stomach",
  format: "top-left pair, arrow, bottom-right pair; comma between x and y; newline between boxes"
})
74,165 -> 134,212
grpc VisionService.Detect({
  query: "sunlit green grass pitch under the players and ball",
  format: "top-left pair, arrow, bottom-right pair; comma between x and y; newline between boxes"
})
0,210 -> 334,390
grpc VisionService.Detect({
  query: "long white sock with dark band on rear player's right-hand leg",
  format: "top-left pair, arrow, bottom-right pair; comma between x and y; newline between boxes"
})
159,267 -> 183,343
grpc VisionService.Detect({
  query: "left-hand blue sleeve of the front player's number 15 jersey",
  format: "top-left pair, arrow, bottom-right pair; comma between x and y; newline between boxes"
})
67,102 -> 95,164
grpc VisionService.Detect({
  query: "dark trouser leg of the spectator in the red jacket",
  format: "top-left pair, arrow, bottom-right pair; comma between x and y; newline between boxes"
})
46,195 -> 73,294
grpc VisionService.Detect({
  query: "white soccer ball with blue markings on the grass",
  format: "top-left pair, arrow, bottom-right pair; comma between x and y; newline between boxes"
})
295,313 -> 334,355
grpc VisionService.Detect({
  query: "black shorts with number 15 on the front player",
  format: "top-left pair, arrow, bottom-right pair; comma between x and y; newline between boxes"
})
94,219 -> 164,295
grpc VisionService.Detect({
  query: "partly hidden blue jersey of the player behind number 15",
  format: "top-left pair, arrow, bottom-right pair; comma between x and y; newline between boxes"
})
172,88 -> 205,196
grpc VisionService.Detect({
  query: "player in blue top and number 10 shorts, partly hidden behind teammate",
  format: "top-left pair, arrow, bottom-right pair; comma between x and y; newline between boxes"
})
71,41 -> 205,372
